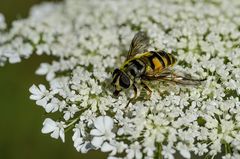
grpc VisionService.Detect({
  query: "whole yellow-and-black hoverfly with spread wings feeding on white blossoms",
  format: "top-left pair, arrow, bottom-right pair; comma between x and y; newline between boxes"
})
112,32 -> 203,99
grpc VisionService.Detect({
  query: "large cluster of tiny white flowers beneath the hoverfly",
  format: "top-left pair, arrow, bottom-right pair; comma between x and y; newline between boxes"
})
0,0 -> 240,159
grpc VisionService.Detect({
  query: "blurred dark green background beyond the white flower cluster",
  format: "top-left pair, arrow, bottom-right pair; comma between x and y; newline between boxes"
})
0,0 -> 106,159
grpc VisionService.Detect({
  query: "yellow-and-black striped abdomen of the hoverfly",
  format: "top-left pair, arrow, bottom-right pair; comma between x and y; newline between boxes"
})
142,51 -> 176,74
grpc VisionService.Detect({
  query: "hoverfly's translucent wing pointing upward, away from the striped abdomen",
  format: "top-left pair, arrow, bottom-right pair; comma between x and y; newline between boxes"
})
127,32 -> 149,60
